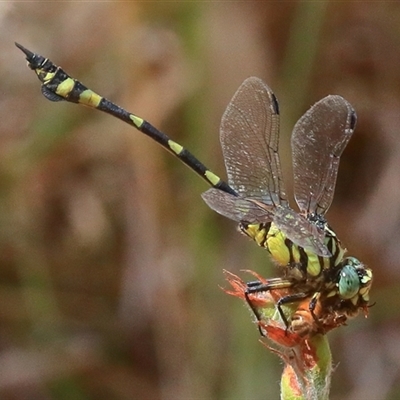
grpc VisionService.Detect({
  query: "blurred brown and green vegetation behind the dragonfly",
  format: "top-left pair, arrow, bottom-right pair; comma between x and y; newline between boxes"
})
0,1 -> 400,400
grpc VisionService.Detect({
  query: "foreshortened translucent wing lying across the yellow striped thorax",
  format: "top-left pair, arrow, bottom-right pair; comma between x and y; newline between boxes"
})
274,207 -> 332,257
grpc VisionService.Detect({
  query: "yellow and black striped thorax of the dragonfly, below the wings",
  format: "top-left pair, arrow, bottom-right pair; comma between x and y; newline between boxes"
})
240,222 -> 345,282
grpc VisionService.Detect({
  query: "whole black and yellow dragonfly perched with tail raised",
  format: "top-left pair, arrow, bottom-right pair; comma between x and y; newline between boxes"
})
16,43 -> 372,338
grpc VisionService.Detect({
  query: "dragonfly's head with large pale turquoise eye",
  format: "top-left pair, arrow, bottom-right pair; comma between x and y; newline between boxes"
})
336,257 -> 372,307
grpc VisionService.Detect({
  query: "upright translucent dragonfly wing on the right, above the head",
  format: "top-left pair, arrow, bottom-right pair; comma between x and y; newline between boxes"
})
292,96 -> 357,215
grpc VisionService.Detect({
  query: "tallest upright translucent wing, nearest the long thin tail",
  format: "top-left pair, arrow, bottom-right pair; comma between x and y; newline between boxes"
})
220,77 -> 286,205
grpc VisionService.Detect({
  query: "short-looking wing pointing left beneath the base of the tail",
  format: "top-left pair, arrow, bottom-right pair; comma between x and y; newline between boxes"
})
201,189 -> 273,223
